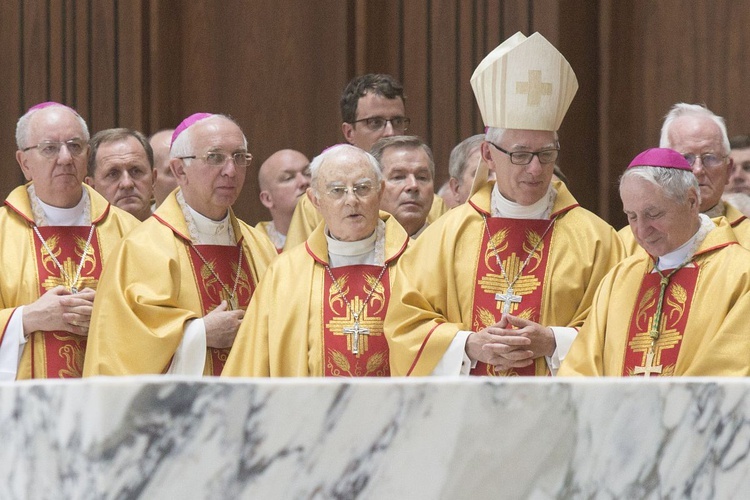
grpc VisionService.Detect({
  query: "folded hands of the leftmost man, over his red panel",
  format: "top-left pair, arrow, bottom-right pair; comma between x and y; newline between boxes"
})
23,285 -> 96,336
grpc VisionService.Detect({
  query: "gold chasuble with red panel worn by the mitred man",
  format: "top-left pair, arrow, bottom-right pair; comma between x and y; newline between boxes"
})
385,181 -> 623,376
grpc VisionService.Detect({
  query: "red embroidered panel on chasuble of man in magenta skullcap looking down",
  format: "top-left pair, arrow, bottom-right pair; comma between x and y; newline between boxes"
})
622,267 -> 698,377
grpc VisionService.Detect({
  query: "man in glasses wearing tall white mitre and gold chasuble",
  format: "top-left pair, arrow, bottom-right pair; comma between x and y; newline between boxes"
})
385,33 -> 623,376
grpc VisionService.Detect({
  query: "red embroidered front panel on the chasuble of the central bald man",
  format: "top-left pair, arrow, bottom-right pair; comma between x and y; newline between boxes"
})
322,265 -> 391,377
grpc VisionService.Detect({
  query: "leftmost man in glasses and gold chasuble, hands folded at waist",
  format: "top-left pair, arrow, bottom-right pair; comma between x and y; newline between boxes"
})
0,102 -> 138,380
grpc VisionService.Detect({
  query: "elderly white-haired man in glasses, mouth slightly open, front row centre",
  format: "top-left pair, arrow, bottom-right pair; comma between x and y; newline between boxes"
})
223,144 -> 409,377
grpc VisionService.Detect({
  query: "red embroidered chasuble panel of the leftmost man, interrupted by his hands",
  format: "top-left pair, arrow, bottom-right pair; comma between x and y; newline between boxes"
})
29,226 -> 102,378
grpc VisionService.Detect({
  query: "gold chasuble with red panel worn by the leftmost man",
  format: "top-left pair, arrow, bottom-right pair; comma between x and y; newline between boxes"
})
0,185 -> 138,379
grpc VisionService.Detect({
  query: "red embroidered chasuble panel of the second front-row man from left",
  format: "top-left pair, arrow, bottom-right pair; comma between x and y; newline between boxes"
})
190,244 -> 255,376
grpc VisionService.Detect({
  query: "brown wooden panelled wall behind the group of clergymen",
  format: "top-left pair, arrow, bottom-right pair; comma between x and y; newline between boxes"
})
0,0 -> 750,227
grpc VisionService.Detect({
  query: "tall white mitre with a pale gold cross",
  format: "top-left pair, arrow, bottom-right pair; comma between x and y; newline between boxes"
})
471,32 -> 578,194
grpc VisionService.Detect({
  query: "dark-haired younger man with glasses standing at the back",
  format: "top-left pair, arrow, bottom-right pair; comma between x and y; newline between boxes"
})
284,73 -> 447,249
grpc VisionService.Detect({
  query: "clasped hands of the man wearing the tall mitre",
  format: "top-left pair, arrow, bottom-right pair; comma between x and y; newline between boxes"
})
466,314 -> 556,371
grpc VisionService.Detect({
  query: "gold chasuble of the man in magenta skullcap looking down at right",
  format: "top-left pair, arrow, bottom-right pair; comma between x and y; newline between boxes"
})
558,218 -> 750,377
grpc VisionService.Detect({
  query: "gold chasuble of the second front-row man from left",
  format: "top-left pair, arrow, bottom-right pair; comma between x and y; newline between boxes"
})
84,190 -> 277,376
